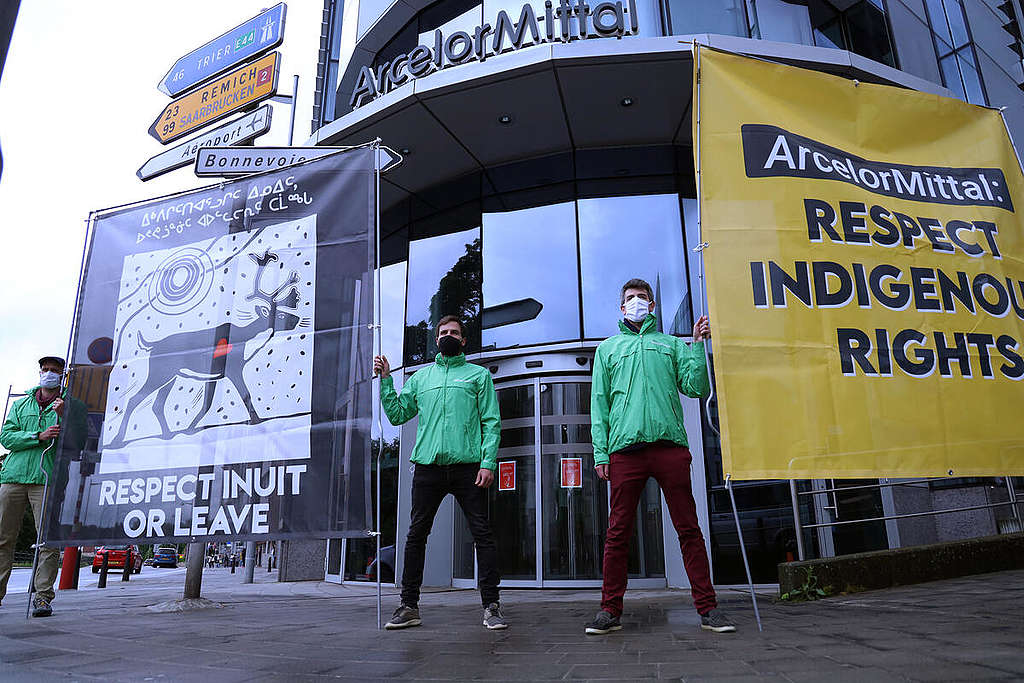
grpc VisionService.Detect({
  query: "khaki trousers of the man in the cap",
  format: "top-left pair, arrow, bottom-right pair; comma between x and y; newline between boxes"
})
0,483 -> 60,602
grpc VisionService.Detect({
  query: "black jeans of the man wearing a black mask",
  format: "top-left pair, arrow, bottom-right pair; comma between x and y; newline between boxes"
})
401,463 -> 501,607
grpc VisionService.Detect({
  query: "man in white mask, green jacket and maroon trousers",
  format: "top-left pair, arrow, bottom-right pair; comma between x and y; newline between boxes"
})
586,280 -> 736,635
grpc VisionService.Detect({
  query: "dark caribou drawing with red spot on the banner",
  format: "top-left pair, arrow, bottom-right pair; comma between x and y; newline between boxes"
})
106,250 -> 302,449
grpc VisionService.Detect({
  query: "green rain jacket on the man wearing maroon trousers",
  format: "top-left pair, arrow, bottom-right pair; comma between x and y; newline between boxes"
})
590,314 -> 711,465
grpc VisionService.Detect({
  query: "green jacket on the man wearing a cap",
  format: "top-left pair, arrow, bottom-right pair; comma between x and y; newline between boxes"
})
0,387 -> 86,484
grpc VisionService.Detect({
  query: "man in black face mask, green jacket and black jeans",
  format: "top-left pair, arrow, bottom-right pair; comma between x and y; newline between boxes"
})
374,315 -> 508,630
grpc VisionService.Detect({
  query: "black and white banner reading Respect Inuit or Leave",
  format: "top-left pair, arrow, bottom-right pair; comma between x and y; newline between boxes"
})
45,147 -> 377,545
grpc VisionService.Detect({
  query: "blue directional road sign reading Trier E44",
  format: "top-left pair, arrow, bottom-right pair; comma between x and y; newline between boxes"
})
157,2 -> 286,97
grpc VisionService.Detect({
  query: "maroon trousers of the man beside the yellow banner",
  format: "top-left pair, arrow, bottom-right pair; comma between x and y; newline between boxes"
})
601,443 -> 718,616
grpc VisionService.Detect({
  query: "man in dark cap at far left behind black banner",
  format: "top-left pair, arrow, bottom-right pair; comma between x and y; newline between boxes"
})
0,355 -> 86,616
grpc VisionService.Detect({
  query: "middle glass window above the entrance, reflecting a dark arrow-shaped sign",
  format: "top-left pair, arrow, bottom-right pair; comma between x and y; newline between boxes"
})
482,202 -> 580,348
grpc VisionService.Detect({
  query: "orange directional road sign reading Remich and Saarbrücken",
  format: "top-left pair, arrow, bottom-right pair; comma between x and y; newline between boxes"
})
150,52 -> 281,144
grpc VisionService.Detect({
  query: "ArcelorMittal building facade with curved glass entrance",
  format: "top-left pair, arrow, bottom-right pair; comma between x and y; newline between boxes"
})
309,0 -> 1024,587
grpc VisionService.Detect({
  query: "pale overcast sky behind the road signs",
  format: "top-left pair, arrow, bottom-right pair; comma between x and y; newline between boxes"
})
0,0 -> 324,405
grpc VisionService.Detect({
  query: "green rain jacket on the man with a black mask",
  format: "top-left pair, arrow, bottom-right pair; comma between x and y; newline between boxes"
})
381,353 -> 501,470
